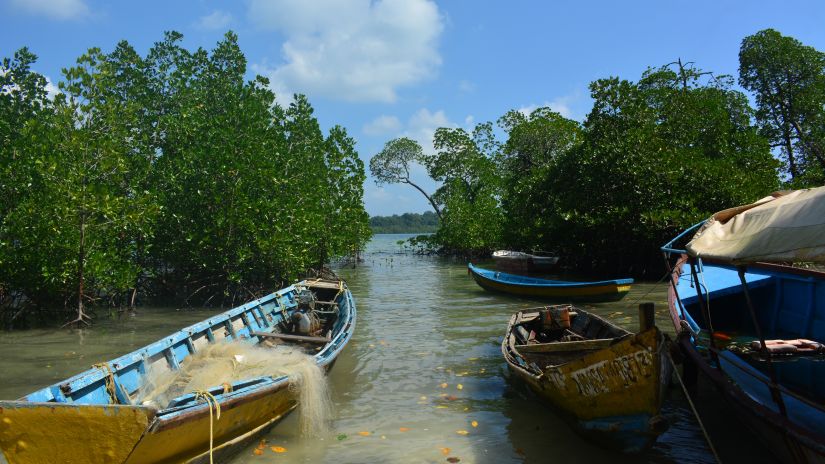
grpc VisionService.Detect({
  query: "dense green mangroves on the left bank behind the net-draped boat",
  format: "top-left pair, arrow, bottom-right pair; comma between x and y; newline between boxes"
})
0,32 -> 370,320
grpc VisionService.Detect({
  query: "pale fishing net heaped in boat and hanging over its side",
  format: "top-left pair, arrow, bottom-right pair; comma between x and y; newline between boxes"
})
138,343 -> 331,435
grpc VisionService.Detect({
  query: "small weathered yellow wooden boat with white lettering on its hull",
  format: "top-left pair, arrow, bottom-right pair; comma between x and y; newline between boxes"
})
501,305 -> 671,453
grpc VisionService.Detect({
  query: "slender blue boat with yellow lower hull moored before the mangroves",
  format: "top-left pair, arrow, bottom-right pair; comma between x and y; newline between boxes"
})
467,263 -> 633,302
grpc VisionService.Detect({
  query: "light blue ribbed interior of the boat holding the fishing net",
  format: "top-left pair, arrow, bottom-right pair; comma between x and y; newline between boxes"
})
21,279 -> 352,414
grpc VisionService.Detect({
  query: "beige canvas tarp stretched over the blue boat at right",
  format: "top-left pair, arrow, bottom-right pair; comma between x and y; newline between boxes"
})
687,187 -> 825,264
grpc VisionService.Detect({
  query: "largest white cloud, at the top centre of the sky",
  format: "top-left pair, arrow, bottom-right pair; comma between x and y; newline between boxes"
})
249,0 -> 443,102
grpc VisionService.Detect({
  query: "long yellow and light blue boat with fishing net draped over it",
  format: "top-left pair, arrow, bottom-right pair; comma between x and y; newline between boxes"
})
0,279 -> 356,464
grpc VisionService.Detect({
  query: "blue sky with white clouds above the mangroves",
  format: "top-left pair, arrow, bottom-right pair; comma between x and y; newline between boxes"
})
0,0 -> 825,215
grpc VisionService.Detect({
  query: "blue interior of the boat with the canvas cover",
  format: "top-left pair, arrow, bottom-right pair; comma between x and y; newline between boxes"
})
677,263 -> 825,424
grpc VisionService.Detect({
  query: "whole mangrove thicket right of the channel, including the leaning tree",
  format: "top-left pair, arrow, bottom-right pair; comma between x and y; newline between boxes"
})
373,61 -> 779,277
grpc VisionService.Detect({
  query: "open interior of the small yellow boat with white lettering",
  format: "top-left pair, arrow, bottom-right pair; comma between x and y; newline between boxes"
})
509,305 -> 632,371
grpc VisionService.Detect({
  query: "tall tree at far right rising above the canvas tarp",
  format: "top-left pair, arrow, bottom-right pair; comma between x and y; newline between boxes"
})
739,29 -> 825,187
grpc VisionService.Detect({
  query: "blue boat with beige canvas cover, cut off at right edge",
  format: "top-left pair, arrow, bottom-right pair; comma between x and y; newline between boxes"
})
662,187 -> 825,463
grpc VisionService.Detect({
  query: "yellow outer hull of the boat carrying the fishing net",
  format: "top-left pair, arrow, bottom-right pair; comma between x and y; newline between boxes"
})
0,382 -> 297,464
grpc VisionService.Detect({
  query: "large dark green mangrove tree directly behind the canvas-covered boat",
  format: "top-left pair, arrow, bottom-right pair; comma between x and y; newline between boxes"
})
545,63 -> 778,274
